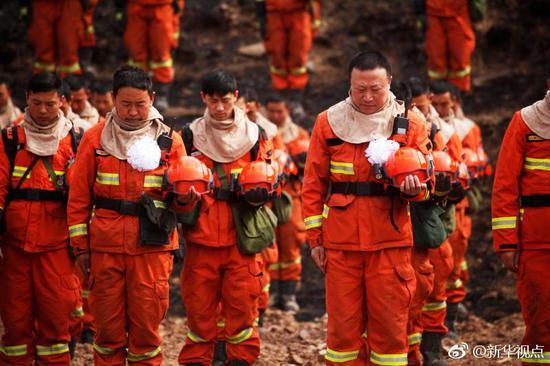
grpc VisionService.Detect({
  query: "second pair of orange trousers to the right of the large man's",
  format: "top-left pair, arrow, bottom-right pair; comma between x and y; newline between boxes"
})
421,240 -> 453,334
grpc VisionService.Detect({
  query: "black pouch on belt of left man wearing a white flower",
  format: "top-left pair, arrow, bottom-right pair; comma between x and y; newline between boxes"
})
139,194 -> 177,245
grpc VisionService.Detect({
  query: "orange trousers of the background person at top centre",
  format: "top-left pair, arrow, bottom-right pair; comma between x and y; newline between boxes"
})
265,11 -> 312,90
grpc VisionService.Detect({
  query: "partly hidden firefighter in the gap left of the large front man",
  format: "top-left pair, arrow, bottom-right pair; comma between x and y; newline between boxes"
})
266,96 -> 309,311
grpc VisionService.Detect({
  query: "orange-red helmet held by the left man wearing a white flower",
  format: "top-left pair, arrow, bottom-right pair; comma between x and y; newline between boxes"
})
165,156 -> 213,194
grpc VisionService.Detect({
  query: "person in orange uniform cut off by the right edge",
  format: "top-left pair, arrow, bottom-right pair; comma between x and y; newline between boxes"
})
492,73 -> 550,366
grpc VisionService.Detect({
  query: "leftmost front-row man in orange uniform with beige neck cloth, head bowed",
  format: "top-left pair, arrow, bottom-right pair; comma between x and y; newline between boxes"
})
0,73 -> 83,366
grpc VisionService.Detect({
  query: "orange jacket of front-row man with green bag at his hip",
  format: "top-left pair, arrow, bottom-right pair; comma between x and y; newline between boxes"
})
183,127 -> 272,247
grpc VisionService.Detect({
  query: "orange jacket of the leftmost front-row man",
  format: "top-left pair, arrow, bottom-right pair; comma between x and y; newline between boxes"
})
0,126 -> 75,253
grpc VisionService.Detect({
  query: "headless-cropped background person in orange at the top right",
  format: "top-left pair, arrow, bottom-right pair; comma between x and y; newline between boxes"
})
426,0 -> 475,93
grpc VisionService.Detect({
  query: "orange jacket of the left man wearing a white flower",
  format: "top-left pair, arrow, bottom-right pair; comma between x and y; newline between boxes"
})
68,123 -> 186,254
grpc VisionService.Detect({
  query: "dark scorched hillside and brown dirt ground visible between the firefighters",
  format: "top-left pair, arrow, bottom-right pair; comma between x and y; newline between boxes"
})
0,0 -> 550,366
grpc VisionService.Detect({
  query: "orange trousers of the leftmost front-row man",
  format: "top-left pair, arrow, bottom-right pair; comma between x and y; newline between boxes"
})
0,245 -> 82,366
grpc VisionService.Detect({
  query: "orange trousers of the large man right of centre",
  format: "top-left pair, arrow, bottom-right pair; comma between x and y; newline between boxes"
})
325,248 -> 416,365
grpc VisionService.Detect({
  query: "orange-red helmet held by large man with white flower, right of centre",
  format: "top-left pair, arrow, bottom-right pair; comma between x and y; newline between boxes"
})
384,147 -> 430,187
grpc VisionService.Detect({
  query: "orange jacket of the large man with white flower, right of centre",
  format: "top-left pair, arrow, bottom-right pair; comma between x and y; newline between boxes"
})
302,111 -> 431,251
